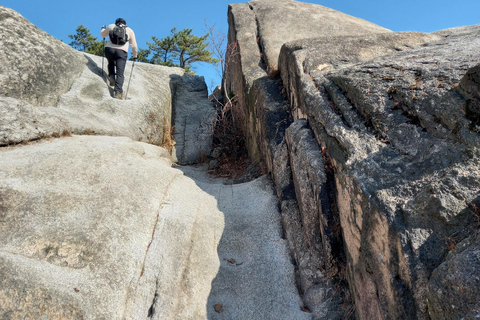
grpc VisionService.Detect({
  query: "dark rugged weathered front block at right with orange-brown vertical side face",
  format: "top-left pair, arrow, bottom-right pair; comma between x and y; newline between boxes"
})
280,27 -> 479,319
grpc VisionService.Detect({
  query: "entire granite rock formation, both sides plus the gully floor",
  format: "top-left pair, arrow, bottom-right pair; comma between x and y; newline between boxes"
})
0,0 -> 480,320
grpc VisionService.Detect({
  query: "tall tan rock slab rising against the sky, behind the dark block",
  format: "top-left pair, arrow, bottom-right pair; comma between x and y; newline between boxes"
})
224,0 -> 389,158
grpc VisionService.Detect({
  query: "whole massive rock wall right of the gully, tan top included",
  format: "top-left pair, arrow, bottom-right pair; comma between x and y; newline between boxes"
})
224,1 -> 480,319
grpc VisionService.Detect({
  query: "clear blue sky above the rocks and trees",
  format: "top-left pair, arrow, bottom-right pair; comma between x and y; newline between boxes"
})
0,0 -> 480,92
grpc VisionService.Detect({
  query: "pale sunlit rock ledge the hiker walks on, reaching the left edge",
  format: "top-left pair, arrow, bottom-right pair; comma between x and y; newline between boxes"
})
0,48 -> 183,145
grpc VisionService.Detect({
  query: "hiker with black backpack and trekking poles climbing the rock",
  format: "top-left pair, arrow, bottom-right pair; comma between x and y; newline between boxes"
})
100,18 -> 138,100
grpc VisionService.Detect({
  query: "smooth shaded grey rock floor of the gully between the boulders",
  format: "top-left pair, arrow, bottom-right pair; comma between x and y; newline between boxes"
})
180,167 -> 311,319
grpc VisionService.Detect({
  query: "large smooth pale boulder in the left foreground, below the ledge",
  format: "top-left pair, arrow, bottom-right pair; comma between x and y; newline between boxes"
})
0,136 -> 223,319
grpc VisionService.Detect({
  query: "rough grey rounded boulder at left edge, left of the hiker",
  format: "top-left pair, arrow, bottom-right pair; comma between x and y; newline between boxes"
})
0,7 -> 86,106
